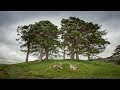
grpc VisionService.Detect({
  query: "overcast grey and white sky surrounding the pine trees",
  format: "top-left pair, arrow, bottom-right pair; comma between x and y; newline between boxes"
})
0,11 -> 120,64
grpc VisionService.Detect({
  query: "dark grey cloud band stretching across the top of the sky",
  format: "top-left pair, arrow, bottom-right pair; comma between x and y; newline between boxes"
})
0,11 -> 120,26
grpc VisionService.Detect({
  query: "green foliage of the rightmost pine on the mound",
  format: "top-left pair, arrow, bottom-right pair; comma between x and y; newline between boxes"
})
83,22 -> 110,59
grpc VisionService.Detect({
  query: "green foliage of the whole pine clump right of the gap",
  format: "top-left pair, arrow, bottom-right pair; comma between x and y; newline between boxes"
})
61,17 -> 110,59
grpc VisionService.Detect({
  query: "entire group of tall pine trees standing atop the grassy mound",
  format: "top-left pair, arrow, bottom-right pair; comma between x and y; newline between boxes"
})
16,17 -> 110,62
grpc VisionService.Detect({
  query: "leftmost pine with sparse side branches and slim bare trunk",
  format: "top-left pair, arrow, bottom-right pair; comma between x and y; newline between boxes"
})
16,24 -> 34,62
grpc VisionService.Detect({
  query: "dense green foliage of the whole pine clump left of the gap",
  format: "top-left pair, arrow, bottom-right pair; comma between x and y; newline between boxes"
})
16,20 -> 59,61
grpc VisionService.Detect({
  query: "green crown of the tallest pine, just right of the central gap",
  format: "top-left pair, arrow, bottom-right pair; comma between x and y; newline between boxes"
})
61,17 -> 85,59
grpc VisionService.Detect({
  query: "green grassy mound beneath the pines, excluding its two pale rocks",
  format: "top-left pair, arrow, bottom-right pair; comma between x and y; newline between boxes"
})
0,60 -> 120,79
